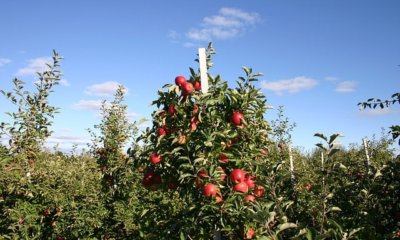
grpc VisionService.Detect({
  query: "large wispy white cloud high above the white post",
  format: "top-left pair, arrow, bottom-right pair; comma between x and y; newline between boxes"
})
186,8 -> 260,41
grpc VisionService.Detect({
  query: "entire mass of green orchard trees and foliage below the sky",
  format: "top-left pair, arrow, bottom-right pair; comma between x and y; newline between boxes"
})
0,44 -> 400,240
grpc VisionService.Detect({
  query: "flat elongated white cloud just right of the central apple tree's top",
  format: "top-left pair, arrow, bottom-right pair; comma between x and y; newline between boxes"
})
261,76 -> 318,95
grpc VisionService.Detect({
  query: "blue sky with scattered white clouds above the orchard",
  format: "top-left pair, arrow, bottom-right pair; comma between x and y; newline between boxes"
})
0,0 -> 400,153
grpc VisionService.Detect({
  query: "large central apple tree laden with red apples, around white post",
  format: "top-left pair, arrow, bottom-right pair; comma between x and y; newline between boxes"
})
138,44 -> 296,239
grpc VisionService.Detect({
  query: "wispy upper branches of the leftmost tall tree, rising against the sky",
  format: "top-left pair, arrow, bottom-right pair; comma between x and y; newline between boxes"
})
0,51 -> 62,157
